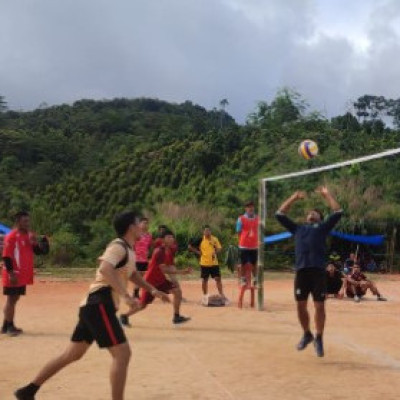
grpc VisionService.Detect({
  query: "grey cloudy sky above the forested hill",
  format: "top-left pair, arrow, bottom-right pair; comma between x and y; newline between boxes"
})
0,0 -> 400,122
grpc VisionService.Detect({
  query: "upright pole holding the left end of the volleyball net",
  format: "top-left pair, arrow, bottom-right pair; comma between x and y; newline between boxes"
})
257,179 -> 267,311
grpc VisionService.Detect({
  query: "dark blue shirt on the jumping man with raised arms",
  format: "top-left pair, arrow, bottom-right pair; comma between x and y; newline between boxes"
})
275,210 -> 343,270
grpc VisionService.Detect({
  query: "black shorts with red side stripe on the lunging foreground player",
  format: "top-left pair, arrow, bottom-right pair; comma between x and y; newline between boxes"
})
71,302 -> 126,348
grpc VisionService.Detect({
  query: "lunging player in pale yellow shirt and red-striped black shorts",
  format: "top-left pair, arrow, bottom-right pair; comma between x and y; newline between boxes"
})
15,211 -> 168,400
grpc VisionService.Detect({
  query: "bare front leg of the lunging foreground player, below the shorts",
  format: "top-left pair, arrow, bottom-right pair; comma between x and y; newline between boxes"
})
108,342 -> 132,400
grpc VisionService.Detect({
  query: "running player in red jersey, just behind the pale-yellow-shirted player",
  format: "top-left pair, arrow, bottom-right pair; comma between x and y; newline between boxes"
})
121,231 -> 191,325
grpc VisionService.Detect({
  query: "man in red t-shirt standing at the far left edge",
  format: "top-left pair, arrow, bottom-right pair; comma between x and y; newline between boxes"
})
1,211 -> 49,336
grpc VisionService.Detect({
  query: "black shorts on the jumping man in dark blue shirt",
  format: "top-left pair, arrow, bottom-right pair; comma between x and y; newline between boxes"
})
294,268 -> 326,301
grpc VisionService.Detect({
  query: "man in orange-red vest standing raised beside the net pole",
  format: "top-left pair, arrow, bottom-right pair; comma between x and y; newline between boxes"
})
236,201 -> 258,285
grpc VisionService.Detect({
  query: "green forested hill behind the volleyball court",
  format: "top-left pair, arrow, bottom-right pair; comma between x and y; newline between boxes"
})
0,90 -> 400,266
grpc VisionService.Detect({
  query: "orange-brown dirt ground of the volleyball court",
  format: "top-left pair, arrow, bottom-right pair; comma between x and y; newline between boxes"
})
0,277 -> 400,400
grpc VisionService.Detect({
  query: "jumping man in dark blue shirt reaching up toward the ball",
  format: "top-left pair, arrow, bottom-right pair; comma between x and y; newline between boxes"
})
276,186 -> 343,357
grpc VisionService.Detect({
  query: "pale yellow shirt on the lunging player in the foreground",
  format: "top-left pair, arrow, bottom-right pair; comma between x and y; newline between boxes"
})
80,239 -> 136,309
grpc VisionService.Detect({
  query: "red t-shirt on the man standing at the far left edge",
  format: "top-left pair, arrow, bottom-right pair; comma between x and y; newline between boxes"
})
2,229 -> 34,287
